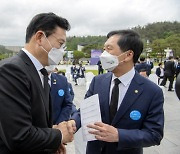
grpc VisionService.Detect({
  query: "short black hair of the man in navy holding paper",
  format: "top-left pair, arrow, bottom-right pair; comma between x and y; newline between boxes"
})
107,30 -> 143,63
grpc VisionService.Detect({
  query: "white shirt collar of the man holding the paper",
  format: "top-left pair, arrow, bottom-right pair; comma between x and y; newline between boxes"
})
112,67 -> 135,86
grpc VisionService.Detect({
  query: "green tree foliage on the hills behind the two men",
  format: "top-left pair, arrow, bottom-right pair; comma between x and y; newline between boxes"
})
0,21 -> 180,59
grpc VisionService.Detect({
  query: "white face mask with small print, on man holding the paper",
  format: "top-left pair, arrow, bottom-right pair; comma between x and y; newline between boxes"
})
100,50 -> 126,71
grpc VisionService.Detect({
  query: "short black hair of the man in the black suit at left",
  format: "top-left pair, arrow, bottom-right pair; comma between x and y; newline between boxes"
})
26,12 -> 70,43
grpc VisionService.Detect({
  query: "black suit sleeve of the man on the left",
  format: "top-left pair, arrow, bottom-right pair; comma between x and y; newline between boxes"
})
0,64 -> 62,153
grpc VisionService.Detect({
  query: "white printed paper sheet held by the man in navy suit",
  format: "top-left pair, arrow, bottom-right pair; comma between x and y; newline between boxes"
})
80,94 -> 102,141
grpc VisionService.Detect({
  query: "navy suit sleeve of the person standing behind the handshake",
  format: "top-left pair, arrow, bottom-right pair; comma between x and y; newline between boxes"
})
56,79 -> 72,124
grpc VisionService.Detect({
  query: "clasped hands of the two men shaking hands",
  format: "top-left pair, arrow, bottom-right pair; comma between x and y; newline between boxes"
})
53,120 -> 76,143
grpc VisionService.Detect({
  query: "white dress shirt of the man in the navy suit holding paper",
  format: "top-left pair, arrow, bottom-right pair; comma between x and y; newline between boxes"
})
109,67 -> 135,110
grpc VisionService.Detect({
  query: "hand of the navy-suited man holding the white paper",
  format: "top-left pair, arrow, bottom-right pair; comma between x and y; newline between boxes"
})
87,122 -> 119,142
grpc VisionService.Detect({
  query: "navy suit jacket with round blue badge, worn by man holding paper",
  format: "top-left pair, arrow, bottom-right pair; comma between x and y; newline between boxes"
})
72,73 -> 164,154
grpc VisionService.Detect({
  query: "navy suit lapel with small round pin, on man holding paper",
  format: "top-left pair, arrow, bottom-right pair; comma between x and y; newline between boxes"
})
112,73 -> 143,125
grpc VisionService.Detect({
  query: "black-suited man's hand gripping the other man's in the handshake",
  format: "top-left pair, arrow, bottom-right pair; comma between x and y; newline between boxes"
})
55,121 -> 74,143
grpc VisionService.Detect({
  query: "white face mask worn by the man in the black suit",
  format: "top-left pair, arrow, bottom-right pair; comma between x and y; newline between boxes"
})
41,34 -> 64,65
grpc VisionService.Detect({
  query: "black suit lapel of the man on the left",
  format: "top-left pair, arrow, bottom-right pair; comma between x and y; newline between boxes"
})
18,50 -> 50,121
